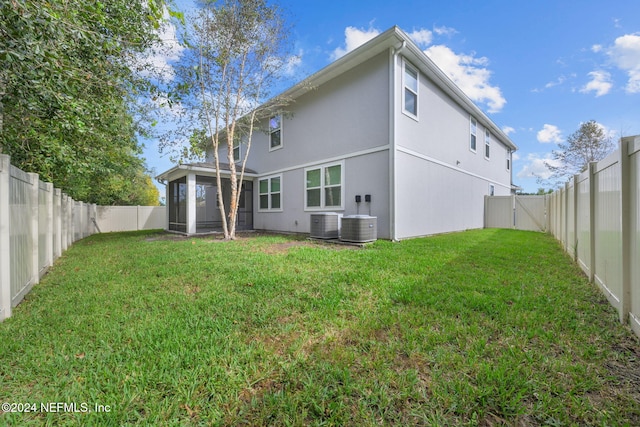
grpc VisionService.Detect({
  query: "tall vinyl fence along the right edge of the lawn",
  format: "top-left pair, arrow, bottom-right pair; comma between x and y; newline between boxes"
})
485,136 -> 640,336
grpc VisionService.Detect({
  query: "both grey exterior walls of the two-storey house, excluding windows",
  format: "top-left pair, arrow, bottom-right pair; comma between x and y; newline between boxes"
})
190,30 -> 515,239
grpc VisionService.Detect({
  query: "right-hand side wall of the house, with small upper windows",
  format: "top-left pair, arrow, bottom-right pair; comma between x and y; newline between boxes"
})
394,56 -> 511,239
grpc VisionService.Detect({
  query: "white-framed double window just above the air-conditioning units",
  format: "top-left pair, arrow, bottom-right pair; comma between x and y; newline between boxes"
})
304,163 -> 344,210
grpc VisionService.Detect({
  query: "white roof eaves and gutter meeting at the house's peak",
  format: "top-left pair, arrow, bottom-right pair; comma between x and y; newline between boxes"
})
265,26 -> 518,151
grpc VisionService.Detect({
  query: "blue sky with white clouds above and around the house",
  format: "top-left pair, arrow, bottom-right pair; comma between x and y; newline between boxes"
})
144,0 -> 640,196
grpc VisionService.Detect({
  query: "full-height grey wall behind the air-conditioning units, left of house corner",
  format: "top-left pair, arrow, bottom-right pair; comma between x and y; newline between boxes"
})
209,51 -> 390,238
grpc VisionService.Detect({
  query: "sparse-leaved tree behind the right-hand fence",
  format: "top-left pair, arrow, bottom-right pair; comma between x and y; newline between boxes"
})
545,120 -> 615,185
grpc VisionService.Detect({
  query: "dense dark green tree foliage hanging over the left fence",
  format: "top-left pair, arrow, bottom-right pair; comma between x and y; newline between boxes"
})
0,0 -> 164,204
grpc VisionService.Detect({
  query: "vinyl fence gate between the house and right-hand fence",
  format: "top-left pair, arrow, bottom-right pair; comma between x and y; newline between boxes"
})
484,195 -> 547,231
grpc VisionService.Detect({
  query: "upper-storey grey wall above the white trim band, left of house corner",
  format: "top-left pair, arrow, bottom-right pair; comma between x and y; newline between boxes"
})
212,52 -> 389,174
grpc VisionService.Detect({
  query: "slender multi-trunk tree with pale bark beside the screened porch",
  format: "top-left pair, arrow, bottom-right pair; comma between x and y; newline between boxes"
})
169,0 -> 287,240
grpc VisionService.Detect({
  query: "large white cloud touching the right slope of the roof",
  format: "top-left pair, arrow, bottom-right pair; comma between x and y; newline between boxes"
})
425,45 -> 507,113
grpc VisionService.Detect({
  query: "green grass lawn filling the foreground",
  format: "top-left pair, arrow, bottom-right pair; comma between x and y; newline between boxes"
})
0,230 -> 640,426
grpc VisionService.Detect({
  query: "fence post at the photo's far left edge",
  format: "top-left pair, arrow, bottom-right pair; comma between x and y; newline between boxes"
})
0,154 -> 11,321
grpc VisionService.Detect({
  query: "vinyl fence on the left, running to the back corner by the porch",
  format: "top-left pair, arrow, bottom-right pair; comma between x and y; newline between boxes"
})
0,154 -> 166,321
